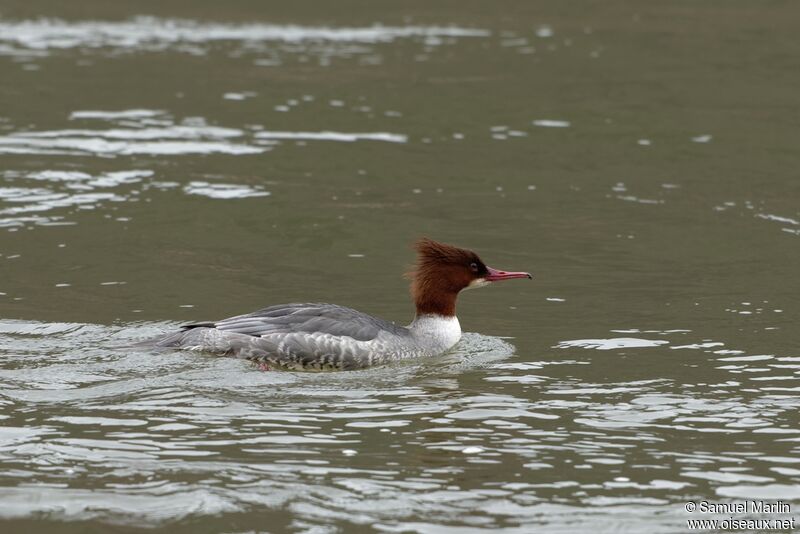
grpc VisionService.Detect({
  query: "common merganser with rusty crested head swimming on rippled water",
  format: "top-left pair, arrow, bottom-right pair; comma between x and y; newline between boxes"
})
146,238 -> 533,371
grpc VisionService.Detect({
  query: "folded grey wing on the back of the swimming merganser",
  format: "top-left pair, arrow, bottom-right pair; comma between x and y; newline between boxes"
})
208,303 -> 408,341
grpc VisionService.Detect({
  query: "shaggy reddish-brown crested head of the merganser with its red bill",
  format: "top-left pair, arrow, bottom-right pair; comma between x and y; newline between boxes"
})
411,237 -> 531,316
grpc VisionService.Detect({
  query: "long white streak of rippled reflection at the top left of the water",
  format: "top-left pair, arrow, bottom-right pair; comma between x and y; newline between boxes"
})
0,17 -> 491,69
